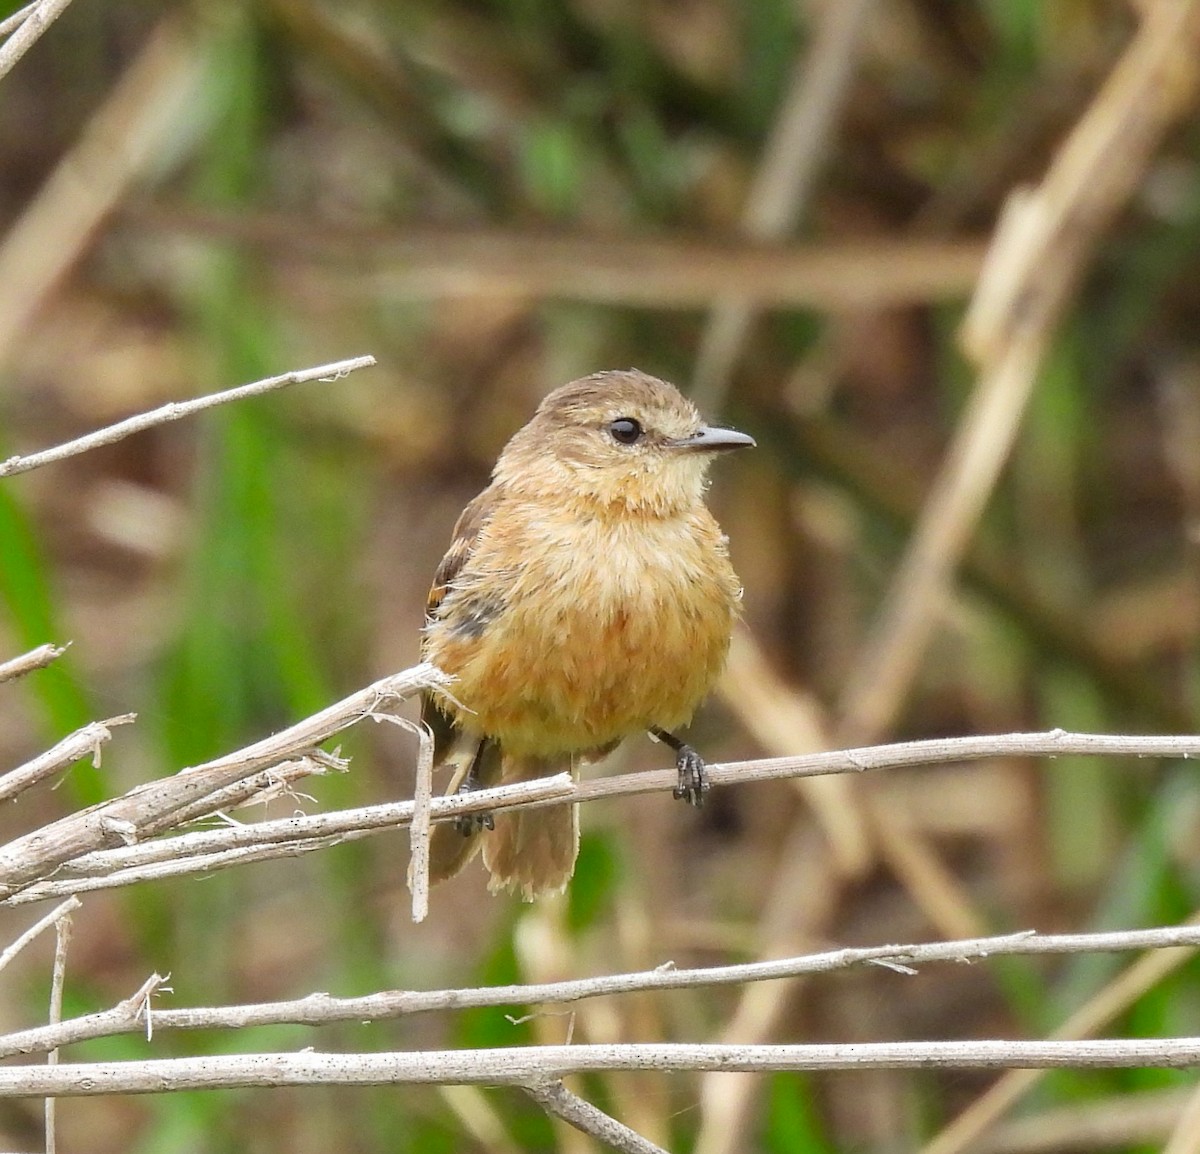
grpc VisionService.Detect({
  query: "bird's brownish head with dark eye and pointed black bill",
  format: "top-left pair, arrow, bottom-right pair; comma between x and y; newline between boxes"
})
496,368 -> 754,516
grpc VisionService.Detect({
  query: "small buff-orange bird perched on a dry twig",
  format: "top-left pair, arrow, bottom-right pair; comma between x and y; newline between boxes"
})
421,369 -> 754,901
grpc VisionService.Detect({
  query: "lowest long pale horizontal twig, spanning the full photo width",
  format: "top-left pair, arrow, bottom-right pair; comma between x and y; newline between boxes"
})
0,1038 -> 1200,1098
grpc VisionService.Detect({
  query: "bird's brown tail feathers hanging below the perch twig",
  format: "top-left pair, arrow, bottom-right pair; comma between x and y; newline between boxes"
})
430,755 -> 580,902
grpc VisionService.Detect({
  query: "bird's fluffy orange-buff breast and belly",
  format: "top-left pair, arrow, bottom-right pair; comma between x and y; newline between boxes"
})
427,523 -> 738,755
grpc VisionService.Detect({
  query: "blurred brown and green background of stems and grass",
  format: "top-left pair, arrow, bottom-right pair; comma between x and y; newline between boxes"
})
0,0 -> 1200,1154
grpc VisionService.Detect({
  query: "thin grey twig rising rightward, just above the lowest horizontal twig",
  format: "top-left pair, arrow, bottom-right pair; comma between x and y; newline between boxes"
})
0,926 -> 1200,1058
